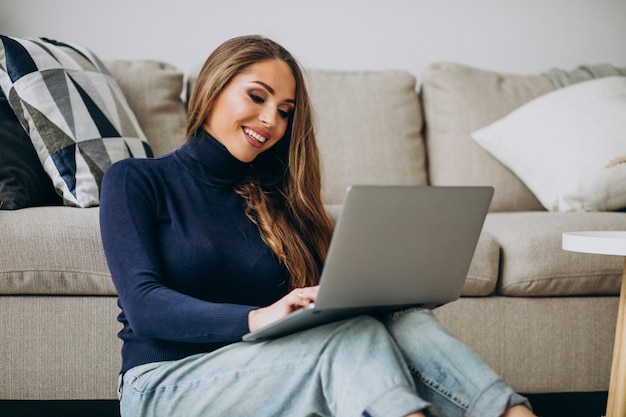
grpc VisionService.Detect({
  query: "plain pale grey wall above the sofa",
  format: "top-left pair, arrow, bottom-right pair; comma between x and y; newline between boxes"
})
0,0 -> 626,79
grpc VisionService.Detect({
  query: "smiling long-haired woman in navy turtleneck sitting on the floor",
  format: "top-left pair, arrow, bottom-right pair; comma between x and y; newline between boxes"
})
100,36 -> 532,417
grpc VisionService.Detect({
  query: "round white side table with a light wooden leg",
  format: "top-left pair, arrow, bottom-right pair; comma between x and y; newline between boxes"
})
563,231 -> 626,417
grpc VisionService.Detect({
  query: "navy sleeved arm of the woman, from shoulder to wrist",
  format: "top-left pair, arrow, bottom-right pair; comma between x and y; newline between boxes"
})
100,159 -> 257,343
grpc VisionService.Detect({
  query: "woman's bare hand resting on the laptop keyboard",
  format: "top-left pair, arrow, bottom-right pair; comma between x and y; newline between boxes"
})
248,285 -> 319,332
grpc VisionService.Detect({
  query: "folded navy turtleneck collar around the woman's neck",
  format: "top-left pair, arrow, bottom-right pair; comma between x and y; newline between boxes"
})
180,129 -> 250,186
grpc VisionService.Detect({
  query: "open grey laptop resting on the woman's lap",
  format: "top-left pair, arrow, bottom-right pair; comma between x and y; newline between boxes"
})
243,185 -> 493,342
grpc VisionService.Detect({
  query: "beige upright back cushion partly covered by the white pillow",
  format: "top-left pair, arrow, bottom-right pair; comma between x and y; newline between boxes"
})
421,63 -> 554,211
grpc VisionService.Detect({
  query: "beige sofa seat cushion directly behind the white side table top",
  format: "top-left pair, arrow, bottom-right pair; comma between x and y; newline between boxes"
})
483,212 -> 626,297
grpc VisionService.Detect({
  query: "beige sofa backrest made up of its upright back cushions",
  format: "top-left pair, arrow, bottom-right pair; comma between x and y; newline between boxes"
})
112,60 -> 555,211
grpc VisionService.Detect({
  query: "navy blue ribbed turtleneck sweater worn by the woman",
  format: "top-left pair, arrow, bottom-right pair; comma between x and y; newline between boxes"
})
100,131 -> 288,372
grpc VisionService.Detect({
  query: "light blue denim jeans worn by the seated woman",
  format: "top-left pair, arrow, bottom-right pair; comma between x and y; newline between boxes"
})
120,310 -> 525,417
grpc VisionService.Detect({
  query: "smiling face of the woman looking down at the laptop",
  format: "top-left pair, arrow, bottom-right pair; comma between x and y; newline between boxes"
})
203,60 -> 296,162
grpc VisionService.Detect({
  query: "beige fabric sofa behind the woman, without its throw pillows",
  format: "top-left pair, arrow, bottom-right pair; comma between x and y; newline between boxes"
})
0,61 -> 626,400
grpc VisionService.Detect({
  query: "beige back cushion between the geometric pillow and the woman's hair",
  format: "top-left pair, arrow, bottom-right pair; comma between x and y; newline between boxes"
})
105,60 -> 187,156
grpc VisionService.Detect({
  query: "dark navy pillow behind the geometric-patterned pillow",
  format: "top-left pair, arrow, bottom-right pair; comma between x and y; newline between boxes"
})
0,90 -> 62,210
